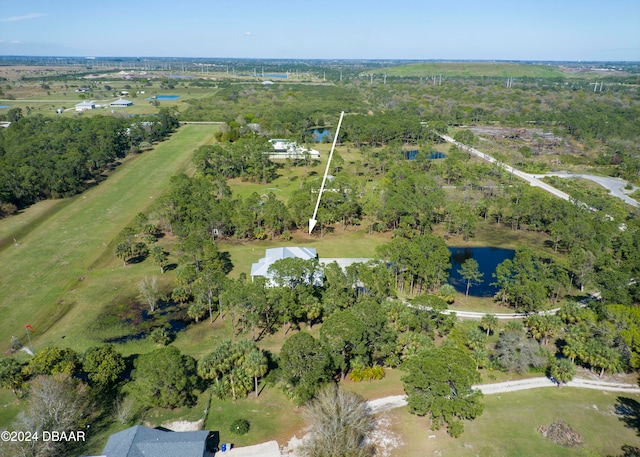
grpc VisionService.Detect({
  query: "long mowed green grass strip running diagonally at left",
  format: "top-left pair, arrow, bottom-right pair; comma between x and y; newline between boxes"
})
0,125 -> 216,350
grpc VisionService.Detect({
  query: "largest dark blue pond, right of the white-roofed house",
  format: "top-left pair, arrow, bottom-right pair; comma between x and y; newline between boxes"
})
449,247 -> 515,297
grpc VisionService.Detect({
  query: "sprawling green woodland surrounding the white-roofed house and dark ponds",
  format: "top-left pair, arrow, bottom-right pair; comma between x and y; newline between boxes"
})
0,62 -> 640,455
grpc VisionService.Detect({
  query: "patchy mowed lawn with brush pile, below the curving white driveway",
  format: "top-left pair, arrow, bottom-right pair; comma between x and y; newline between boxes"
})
385,388 -> 640,457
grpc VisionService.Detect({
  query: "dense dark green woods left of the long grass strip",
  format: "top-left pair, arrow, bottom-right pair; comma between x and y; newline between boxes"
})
0,110 -> 178,216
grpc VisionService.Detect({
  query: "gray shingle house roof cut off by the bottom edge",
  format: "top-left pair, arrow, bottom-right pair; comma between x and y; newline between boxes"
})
102,425 -> 211,457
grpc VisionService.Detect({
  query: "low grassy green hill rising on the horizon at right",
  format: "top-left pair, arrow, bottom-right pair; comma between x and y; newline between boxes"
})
378,62 -> 566,78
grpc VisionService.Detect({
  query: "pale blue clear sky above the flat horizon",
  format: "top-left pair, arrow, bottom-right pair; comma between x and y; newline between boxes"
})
0,0 -> 640,61
